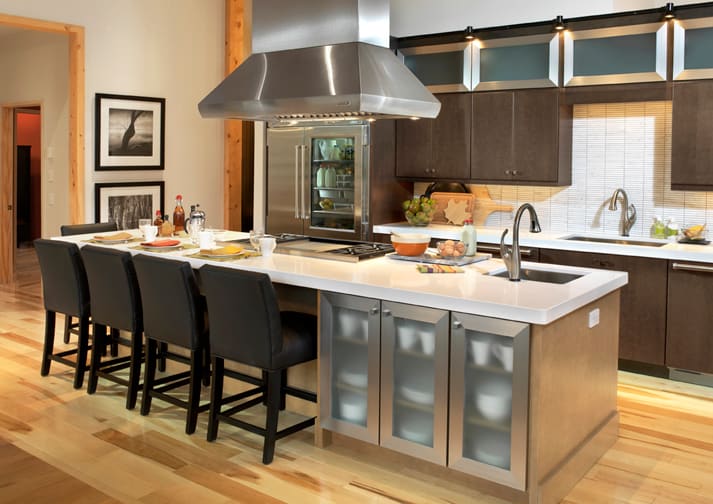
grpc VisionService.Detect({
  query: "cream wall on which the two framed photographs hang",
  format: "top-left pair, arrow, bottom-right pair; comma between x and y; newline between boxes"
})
0,0 -> 224,235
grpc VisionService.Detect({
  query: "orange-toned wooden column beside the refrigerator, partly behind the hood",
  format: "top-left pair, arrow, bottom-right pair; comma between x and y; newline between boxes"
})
223,0 -> 253,231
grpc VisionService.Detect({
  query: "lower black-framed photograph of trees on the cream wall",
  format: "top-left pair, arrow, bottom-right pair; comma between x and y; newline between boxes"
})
94,181 -> 164,229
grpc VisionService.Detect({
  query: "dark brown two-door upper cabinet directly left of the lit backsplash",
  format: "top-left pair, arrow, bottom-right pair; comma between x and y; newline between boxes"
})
470,89 -> 572,185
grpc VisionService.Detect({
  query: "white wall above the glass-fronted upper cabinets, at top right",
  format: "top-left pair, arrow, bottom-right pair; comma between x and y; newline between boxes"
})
391,0 -> 699,37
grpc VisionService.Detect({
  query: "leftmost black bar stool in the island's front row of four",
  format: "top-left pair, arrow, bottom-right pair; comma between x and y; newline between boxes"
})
34,239 -> 90,388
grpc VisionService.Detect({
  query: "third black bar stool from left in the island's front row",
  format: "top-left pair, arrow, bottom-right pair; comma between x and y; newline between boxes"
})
134,254 -> 210,434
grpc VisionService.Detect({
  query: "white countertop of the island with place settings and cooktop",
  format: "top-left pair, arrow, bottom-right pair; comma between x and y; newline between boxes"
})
58,231 -> 627,324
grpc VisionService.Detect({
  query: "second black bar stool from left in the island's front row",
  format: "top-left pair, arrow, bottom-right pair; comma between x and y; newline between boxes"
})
81,245 -> 144,409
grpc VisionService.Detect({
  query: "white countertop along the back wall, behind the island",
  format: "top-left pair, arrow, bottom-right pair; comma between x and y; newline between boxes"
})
374,223 -> 713,263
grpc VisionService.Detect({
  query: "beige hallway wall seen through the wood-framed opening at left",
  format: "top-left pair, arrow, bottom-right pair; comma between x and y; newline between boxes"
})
0,32 -> 69,236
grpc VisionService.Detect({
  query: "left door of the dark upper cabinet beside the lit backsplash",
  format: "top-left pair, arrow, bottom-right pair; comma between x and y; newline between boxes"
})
470,91 -> 515,181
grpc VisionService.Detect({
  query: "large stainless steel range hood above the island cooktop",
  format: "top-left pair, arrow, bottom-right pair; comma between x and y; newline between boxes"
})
198,0 -> 441,121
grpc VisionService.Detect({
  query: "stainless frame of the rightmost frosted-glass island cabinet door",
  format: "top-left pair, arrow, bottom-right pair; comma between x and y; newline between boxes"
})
448,313 -> 530,490
